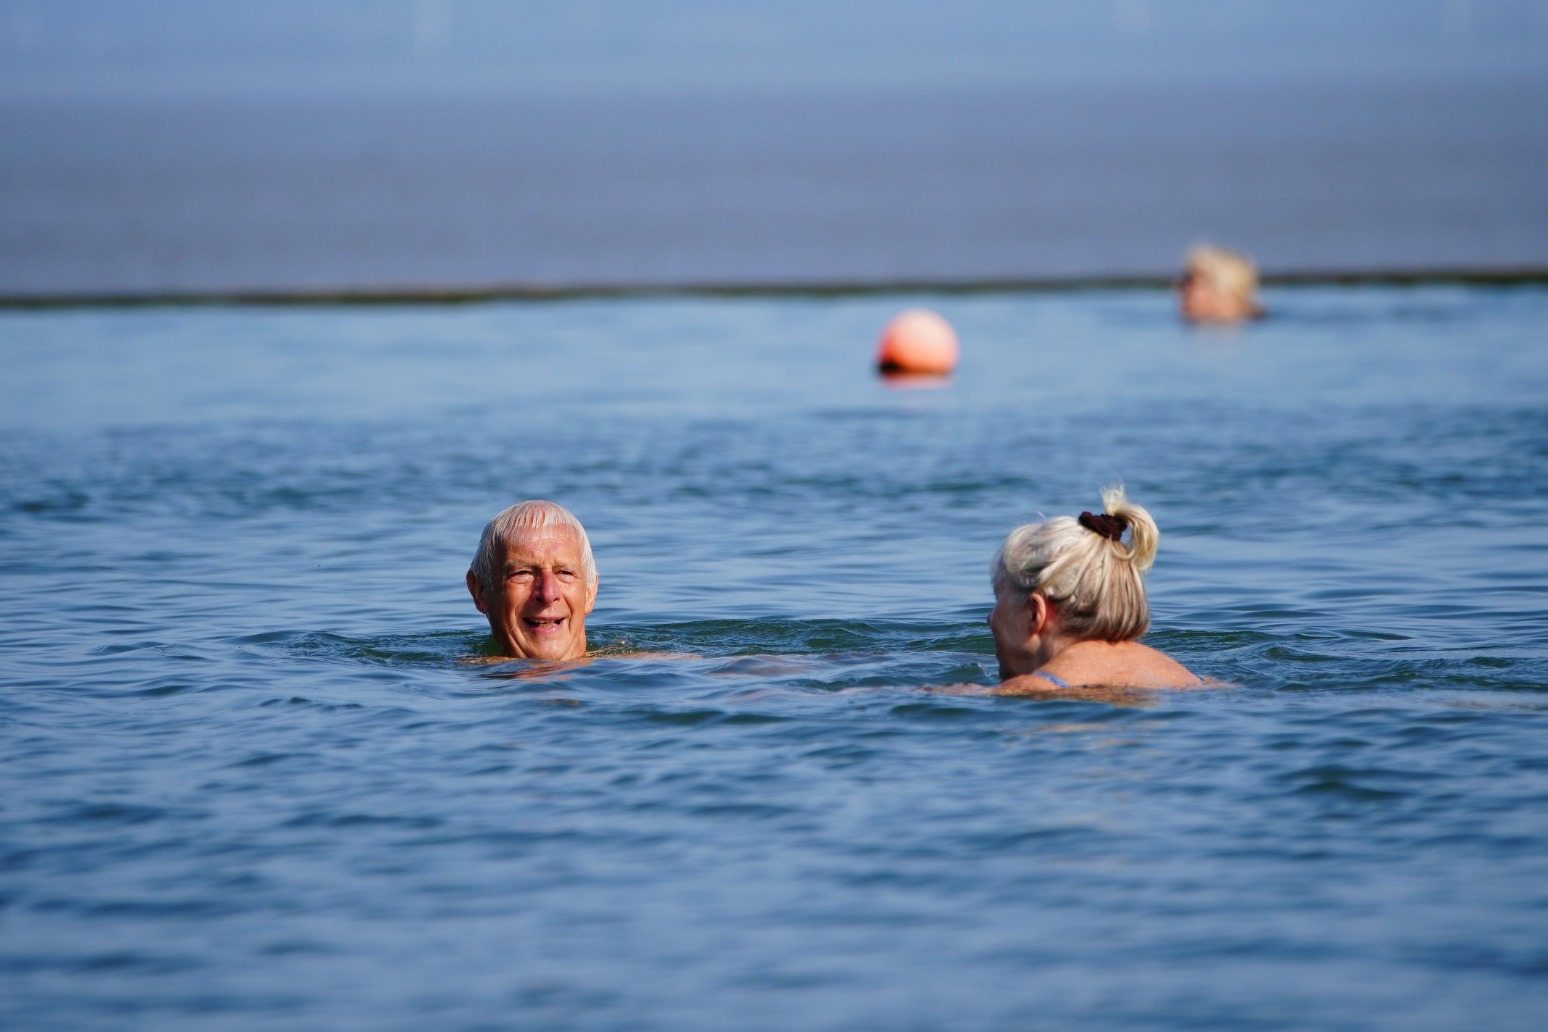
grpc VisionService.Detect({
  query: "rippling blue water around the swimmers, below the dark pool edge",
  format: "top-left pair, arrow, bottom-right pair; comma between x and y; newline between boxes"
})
0,286 -> 1548,1030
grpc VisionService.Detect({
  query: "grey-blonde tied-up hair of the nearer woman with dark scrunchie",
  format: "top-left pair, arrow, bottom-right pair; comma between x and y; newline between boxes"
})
991,484 -> 1161,642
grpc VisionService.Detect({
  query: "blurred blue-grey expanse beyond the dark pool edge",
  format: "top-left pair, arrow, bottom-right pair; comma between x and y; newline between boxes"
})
0,0 -> 1548,299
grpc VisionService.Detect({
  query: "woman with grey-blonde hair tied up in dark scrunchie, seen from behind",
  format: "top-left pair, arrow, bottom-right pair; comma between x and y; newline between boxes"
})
989,486 -> 1203,695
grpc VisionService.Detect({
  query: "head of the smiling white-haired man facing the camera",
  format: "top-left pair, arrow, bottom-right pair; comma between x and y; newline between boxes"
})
467,501 -> 596,659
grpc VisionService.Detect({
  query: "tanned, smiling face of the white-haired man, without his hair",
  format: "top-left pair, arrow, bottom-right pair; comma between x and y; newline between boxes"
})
467,526 -> 596,659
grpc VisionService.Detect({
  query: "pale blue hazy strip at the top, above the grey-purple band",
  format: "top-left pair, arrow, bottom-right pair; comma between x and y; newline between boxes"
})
0,0 -> 1548,101
